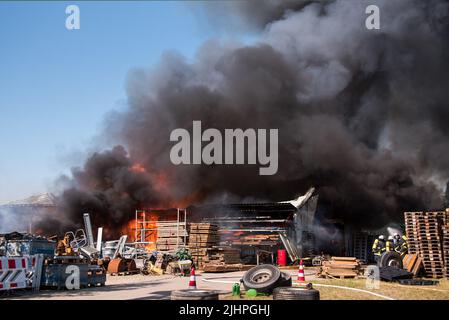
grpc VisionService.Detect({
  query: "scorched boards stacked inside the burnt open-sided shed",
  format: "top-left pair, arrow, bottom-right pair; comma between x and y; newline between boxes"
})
220,230 -> 280,246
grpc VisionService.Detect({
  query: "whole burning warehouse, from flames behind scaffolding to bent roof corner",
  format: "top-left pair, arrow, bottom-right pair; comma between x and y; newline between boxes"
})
125,188 -> 318,263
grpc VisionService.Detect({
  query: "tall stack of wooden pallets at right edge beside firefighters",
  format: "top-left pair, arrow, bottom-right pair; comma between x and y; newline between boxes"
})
404,211 -> 449,278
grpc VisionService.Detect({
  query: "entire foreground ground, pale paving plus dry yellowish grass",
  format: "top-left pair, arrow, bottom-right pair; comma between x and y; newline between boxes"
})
3,269 -> 449,300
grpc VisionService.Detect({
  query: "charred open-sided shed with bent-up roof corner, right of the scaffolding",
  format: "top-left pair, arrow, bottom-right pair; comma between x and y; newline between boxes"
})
187,188 -> 318,262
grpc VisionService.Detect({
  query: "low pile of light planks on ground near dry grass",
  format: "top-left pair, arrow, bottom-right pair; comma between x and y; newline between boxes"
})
317,257 -> 362,279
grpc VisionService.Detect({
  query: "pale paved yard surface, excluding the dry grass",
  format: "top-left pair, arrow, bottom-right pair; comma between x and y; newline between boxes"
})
4,270 -> 314,300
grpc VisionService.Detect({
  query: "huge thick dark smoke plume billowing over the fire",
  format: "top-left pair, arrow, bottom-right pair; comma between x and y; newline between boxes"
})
43,0 -> 449,235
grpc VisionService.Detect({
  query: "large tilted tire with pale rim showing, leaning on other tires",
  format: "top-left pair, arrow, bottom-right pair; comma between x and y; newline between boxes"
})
242,264 -> 281,293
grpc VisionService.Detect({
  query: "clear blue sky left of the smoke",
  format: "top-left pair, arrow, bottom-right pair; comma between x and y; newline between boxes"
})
0,1 -> 252,202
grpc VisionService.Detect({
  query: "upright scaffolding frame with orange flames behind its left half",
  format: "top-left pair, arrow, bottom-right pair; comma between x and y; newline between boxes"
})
134,208 -> 188,253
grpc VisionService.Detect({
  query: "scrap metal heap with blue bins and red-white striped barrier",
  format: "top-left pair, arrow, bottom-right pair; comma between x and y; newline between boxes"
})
0,222 -> 106,291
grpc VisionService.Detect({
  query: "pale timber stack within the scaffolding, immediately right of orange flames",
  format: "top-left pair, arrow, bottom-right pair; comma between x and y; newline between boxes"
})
156,222 -> 187,252
